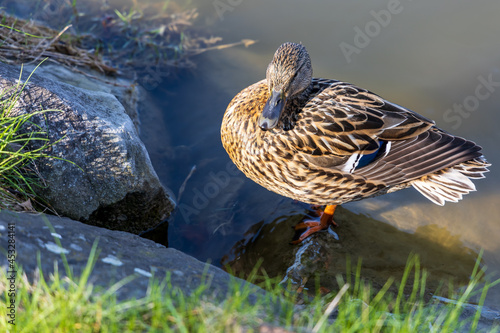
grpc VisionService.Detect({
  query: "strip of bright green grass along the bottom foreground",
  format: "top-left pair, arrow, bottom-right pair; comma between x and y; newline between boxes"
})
0,239 -> 498,333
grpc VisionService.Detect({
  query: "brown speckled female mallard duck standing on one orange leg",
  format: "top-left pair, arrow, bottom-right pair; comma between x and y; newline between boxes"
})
221,43 -> 490,243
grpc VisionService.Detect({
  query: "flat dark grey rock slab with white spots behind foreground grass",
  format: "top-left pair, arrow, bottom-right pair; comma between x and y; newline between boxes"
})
0,211 -> 264,300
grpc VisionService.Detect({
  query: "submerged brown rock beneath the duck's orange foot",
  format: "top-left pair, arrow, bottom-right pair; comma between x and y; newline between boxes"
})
223,207 -> 477,292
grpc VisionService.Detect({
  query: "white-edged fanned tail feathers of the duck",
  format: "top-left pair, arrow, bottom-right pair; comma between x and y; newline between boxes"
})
411,156 -> 490,206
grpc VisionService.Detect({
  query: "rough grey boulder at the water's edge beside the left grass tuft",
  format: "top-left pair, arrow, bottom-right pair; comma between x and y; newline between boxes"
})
0,65 -> 174,233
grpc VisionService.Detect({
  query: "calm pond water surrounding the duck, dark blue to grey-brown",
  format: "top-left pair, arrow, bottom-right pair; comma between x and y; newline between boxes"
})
4,0 -> 500,308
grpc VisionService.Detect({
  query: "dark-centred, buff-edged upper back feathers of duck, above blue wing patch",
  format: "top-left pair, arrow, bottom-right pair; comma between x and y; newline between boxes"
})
290,79 -> 434,156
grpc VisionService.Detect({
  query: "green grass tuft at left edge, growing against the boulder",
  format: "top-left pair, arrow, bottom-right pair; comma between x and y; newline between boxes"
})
0,63 -> 66,210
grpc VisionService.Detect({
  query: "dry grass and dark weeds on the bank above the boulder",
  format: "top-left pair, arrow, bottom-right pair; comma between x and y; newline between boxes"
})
0,0 -> 254,78
